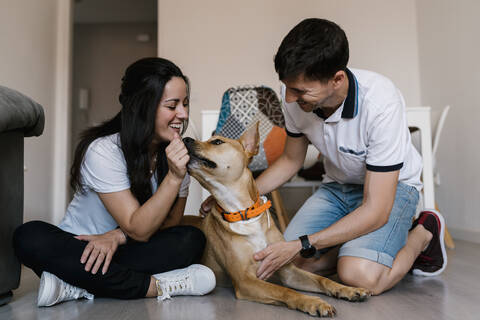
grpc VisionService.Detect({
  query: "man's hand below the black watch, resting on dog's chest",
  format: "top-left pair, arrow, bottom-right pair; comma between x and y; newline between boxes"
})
253,240 -> 302,280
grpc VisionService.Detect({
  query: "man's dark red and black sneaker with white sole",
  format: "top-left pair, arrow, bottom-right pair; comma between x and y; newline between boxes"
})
412,210 -> 447,277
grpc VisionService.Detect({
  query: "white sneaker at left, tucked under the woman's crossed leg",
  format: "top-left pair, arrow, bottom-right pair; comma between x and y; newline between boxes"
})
37,271 -> 94,307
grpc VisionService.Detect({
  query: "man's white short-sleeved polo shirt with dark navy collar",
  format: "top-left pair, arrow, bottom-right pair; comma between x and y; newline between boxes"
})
281,69 -> 422,190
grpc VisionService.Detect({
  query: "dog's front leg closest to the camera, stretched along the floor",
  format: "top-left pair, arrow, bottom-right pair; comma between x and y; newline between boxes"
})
233,277 -> 336,317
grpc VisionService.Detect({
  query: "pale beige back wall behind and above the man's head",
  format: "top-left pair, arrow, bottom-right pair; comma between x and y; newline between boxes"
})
158,0 -> 420,212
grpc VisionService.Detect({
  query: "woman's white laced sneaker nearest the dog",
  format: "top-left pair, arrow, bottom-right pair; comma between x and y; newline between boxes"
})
153,264 -> 216,300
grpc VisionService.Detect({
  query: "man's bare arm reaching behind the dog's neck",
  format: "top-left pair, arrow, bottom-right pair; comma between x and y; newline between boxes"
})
255,136 -> 308,194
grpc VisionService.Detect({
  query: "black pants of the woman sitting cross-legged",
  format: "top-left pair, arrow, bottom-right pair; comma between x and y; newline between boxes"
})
13,221 -> 206,299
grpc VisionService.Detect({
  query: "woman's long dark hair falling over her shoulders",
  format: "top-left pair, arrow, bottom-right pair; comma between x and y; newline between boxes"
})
70,58 -> 190,204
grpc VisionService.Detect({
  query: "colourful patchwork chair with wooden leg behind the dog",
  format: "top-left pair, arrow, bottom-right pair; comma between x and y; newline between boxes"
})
215,85 -> 287,232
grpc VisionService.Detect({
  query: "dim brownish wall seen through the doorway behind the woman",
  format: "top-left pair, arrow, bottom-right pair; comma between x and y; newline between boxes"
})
72,22 -> 157,150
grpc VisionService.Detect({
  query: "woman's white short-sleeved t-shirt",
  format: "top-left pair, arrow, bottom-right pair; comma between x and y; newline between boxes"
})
58,133 -> 190,235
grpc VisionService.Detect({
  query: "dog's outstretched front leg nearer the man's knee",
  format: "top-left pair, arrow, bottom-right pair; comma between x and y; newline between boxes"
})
277,263 -> 371,301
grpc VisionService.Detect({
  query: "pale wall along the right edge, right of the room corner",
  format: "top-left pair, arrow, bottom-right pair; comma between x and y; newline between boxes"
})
417,0 -> 480,242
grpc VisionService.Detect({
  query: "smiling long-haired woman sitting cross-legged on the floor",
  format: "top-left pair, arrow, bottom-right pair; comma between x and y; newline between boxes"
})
14,58 -> 215,306
